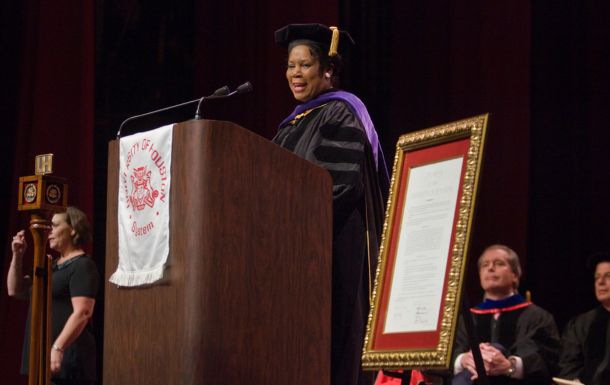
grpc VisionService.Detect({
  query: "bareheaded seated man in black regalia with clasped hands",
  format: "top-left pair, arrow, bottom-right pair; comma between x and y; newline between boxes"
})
452,245 -> 560,385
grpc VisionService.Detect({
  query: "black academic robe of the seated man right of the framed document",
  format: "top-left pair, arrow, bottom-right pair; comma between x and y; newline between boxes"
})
453,304 -> 560,385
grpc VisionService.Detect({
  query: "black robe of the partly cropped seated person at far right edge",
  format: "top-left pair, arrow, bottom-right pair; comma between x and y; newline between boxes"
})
559,306 -> 610,385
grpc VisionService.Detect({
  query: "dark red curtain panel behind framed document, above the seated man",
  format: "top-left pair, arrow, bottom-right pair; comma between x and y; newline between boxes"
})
379,1 -> 531,302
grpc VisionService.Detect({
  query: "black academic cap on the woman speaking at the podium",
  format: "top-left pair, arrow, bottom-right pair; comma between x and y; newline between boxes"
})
275,23 -> 356,56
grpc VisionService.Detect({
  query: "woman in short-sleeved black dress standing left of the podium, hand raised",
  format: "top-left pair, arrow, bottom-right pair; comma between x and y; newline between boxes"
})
7,207 -> 100,385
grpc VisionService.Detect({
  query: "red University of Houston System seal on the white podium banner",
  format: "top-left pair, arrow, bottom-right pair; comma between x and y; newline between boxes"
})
121,138 -> 168,237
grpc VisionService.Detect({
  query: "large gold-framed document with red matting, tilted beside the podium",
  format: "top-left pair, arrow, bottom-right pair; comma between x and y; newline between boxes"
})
362,114 -> 488,370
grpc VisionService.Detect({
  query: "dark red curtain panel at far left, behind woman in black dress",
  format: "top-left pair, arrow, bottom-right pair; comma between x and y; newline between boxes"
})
0,1 -> 94,384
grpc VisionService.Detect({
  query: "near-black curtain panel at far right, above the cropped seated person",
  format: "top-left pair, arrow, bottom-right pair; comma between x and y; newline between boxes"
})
528,0 -> 610,324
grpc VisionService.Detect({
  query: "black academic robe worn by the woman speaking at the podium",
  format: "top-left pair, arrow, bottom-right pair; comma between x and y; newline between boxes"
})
273,100 -> 388,385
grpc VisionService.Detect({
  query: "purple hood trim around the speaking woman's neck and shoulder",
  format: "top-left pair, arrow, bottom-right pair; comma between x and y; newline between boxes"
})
279,91 -> 385,168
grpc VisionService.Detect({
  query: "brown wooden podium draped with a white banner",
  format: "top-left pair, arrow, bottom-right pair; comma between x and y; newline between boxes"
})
104,120 -> 332,385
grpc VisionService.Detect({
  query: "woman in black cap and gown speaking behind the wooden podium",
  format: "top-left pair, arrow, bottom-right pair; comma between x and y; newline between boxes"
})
273,24 -> 388,385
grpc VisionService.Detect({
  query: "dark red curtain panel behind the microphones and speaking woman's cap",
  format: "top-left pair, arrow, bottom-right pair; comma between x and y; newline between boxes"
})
194,0 -> 340,138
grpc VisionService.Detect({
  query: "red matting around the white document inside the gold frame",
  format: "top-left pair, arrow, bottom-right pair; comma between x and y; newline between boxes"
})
372,138 -> 470,350
